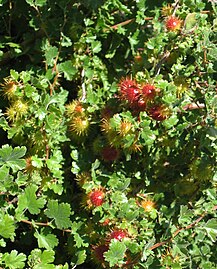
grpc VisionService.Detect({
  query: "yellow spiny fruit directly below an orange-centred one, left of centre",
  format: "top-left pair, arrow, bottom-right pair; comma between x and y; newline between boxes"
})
70,116 -> 90,136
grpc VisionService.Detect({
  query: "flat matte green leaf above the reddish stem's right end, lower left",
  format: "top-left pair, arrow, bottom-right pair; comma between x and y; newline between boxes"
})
45,200 -> 72,229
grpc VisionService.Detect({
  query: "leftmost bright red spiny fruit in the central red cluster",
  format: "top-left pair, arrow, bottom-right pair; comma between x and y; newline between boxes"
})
119,78 -> 140,104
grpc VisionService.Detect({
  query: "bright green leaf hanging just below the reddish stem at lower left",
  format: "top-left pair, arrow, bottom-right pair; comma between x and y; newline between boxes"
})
34,230 -> 59,250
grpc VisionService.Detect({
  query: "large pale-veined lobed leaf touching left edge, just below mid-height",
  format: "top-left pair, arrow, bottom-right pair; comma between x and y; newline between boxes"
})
0,145 -> 26,172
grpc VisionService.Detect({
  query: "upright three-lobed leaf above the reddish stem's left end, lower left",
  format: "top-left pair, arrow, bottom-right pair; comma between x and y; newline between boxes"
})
17,185 -> 46,214
